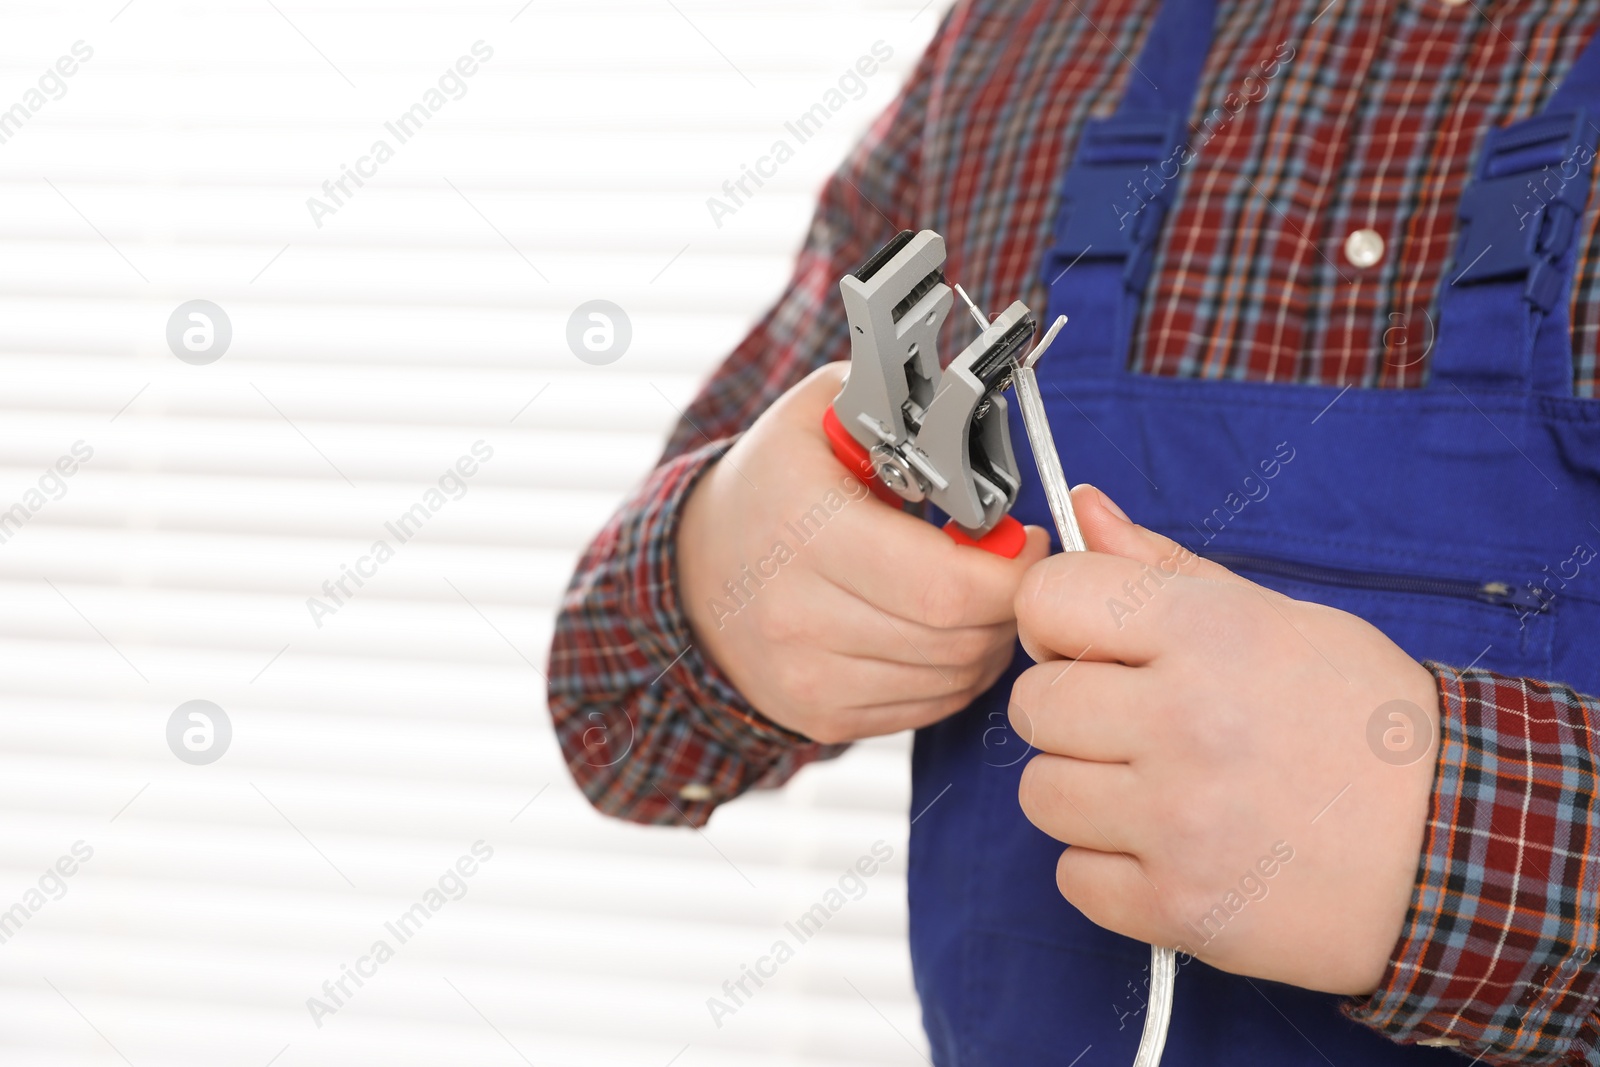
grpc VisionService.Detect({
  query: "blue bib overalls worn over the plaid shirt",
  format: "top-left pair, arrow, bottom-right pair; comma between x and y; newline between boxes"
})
909,0 -> 1600,1067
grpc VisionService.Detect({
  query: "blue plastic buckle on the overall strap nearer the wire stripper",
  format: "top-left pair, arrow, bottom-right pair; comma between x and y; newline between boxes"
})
1051,112 -> 1184,293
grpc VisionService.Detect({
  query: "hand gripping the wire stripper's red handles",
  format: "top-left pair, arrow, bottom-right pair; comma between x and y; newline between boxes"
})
677,363 -> 1050,744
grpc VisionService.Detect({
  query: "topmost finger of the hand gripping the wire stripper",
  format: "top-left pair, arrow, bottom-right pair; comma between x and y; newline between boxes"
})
813,508 -> 1050,629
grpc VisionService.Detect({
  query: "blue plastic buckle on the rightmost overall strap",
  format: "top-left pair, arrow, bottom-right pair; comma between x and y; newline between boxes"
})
1454,107 -> 1600,312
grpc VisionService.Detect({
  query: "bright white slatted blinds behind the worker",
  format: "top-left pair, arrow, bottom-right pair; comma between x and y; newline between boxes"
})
0,0 -> 944,1067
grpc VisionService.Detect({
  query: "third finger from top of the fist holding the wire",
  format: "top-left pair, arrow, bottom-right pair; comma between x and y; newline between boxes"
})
1016,753 -> 1150,854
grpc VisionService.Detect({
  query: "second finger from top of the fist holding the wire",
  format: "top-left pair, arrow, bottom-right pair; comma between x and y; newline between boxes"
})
1010,659 -> 1157,763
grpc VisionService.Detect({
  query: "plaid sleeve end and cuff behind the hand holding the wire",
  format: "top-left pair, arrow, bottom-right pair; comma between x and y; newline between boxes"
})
1346,662 -> 1600,1065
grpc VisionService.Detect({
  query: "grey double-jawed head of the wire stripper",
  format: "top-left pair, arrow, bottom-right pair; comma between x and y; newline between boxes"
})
824,230 -> 1035,555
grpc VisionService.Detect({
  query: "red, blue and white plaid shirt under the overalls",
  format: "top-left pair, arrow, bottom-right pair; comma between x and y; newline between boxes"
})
549,0 -> 1600,1064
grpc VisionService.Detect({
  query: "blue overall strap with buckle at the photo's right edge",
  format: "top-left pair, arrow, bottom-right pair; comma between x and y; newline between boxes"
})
1429,37 -> 1600,397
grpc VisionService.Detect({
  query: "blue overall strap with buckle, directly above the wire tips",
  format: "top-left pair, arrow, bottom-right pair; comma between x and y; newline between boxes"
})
1043,0 -> 1216,379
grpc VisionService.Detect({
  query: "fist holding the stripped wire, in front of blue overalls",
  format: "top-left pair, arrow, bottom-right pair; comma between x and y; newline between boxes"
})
1011,486 -> 1438,993
